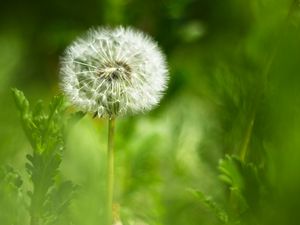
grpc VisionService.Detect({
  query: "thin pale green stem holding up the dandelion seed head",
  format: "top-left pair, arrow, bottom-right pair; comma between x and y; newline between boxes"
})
106,118 -> 115,225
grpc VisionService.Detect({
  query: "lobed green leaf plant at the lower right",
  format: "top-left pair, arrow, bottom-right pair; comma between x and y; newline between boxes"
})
192,155 -> 268,224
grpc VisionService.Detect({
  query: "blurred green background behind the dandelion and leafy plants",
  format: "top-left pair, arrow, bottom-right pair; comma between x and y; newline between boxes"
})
0,0 -> 300,225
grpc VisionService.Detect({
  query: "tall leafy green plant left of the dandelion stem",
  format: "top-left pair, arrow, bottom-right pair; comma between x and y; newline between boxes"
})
12,89 -> 80,225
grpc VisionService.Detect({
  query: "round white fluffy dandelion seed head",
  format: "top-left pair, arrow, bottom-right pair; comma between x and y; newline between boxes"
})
60,27 -> 168,118
